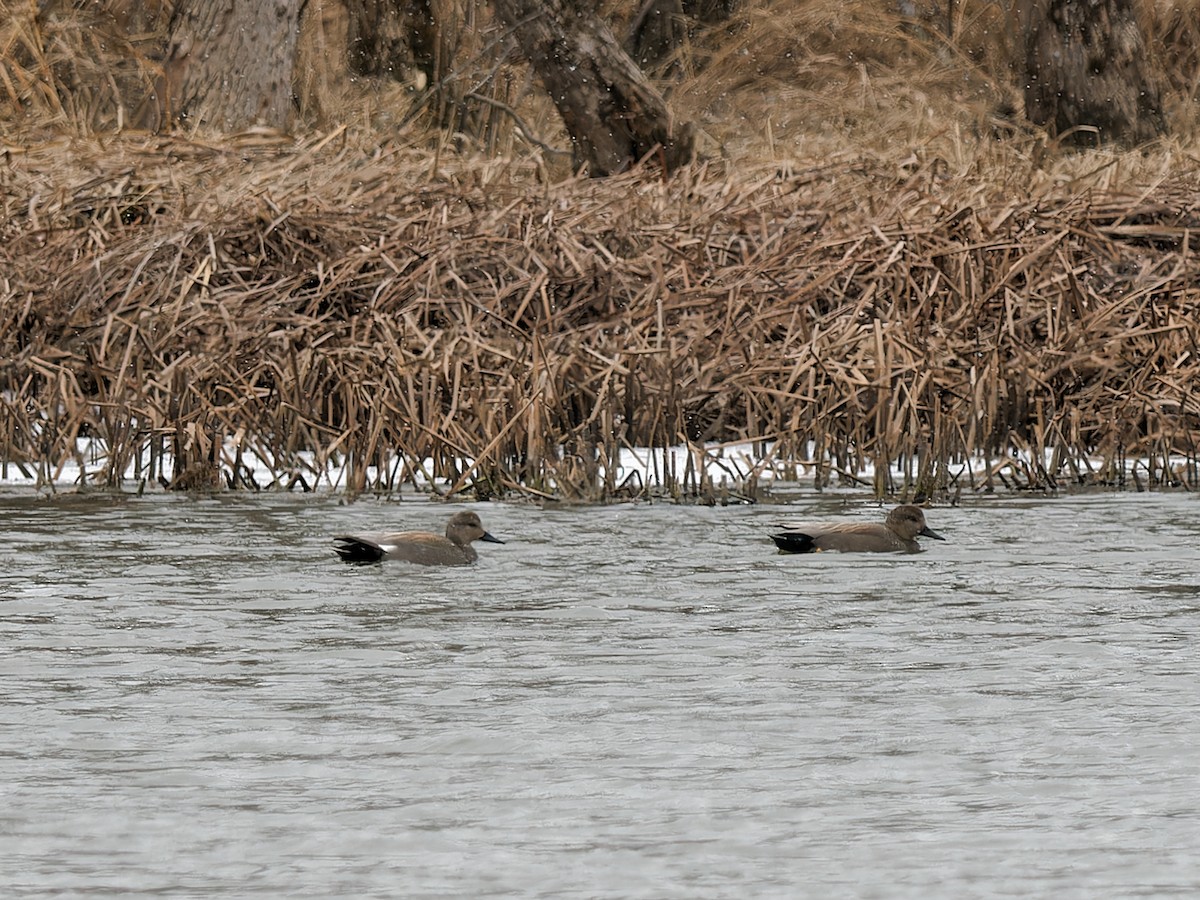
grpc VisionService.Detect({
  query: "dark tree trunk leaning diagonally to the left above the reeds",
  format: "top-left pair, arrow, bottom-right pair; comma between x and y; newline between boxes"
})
492,0 -> 695,176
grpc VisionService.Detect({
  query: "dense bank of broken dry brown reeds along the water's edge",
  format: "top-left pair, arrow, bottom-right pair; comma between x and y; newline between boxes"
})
0,132 -> 1200,502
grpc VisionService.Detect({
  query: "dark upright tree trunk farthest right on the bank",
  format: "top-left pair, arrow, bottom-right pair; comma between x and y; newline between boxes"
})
1025,0 -> 1166,144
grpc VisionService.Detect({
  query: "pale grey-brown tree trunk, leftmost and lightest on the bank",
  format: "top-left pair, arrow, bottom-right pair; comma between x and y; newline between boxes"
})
145,0 -> 302,132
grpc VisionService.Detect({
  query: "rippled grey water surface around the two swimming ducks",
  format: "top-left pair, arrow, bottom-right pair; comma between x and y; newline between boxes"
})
0,494 -> 1200,898
